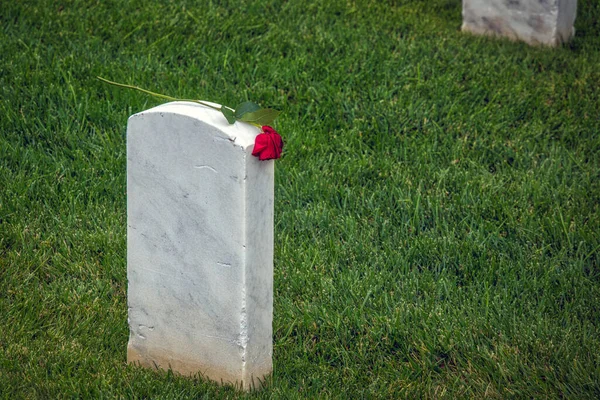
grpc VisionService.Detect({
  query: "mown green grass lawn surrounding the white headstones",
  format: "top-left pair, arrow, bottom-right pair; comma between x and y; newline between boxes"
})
0,0 -> 600,399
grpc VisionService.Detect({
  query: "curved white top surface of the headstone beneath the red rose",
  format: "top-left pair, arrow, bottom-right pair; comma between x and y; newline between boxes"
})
131,100 -> 260,149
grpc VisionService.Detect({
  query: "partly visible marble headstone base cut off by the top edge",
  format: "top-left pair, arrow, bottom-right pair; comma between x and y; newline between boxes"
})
462,0 -> 577,46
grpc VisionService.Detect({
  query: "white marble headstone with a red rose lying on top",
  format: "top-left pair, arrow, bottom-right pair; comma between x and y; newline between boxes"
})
127,102 -> 274,389
